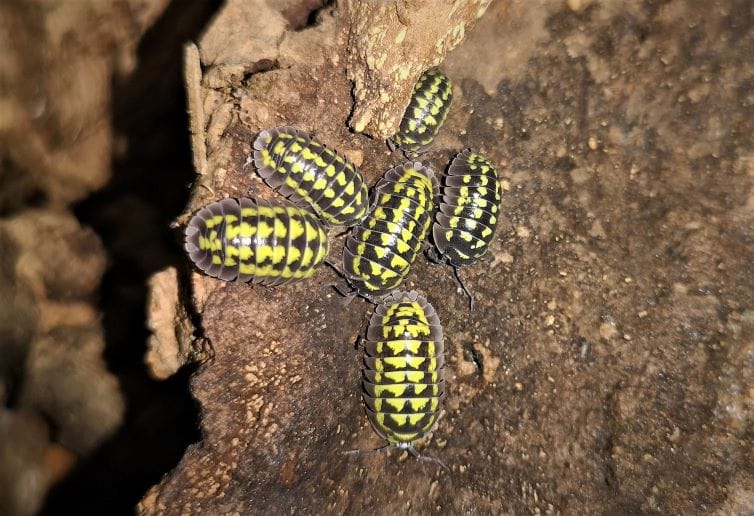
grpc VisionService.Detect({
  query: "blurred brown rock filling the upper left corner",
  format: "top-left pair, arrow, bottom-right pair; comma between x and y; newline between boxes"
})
0,0 -> 167,212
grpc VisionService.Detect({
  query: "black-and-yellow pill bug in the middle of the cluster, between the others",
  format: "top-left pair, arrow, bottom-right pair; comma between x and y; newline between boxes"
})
343,161 -> 439,300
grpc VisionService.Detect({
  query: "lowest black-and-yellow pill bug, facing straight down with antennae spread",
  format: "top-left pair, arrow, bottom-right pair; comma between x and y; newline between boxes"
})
362,291 -> 445,466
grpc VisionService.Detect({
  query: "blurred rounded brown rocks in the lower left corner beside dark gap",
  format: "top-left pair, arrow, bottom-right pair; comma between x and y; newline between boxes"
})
0,209 -> 124,514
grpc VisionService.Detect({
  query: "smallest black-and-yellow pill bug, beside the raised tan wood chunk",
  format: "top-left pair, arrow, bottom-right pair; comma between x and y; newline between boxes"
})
389,68 -> 453,155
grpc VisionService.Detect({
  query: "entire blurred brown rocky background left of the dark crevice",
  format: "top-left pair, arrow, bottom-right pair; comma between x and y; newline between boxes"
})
0,0 -> 173,515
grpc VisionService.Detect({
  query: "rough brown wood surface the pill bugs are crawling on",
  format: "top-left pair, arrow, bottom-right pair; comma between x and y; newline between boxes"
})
139,0 -> 754,514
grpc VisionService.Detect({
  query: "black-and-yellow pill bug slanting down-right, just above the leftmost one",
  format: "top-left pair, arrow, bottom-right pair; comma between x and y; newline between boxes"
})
252,126 -> 369,226
